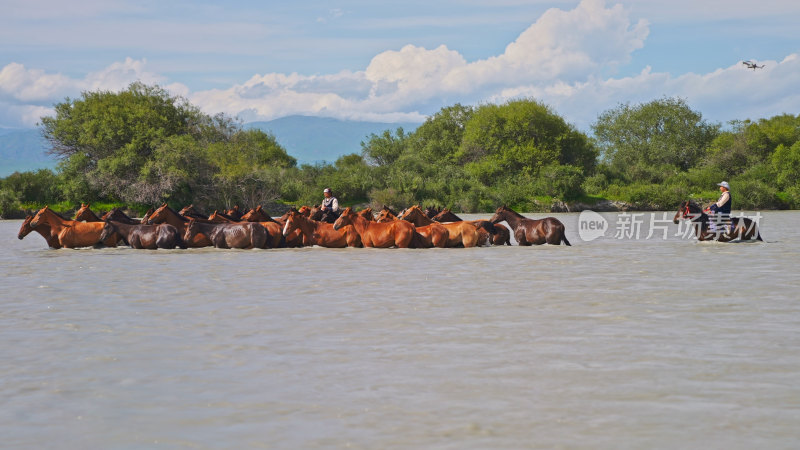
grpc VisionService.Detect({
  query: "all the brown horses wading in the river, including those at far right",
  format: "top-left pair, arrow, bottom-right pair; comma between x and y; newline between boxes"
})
17,201 -> 761,249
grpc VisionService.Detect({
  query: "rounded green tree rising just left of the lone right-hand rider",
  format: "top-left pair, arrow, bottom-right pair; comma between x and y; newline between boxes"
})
592,98 -> 720,182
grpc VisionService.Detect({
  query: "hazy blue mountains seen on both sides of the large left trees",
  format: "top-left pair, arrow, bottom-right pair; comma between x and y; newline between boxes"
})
0,116 -> 421,177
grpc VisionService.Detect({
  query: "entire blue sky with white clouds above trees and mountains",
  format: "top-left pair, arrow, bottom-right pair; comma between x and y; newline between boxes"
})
0,0 -> 800,131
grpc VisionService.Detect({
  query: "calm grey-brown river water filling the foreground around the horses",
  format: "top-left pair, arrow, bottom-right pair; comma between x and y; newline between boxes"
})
0,212 -> 800,449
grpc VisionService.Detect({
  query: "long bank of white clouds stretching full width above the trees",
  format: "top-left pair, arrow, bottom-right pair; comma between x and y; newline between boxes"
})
0,0 -> 800,130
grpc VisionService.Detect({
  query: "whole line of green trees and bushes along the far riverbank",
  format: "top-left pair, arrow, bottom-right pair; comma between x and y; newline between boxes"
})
0,82 -> 800,217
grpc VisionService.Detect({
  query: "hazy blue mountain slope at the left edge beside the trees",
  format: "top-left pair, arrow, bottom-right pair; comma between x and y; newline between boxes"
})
0,128 -> 57,177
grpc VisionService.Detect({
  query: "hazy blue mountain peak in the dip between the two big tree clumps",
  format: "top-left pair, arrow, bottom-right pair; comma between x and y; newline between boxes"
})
244,116 -> 421,164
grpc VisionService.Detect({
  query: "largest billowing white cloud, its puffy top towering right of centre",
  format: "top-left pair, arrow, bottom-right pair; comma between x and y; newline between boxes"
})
184,0 -> 648,120
